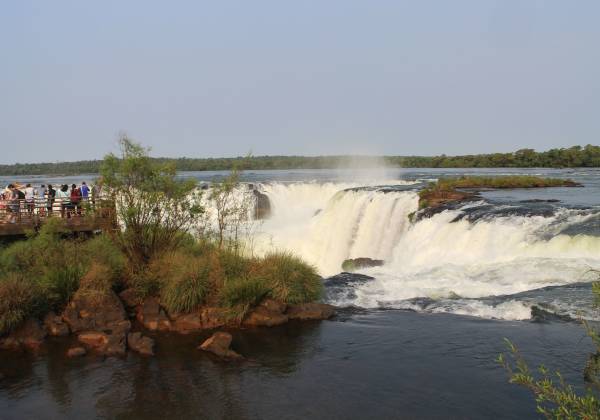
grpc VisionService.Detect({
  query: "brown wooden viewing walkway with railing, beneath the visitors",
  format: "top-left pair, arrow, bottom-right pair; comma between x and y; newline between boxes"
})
0,199 -> 117,237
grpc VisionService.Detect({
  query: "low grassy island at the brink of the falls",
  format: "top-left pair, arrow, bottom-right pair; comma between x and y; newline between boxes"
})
419,175 -> 581,209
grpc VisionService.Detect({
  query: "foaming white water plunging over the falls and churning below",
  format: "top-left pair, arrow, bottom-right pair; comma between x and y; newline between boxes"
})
250,182 -> 600,319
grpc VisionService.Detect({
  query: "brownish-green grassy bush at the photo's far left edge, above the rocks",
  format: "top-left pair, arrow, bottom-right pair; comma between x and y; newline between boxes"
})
0,275 -> 42,335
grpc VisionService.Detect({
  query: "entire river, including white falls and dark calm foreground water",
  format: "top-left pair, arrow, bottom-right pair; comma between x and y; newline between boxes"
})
0,169 -> 600,419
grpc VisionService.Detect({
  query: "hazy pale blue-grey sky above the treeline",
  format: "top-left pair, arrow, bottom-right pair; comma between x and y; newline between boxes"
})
0,0 -> 600,163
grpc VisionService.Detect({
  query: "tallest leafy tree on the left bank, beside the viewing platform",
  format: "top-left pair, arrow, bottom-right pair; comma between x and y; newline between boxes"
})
101,135 -> 204,272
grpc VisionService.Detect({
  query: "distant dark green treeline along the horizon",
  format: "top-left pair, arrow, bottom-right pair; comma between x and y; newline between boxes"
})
0,144 -> 600,175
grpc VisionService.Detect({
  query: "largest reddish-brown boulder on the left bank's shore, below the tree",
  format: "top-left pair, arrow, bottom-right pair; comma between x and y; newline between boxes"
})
63,290 -> 127,333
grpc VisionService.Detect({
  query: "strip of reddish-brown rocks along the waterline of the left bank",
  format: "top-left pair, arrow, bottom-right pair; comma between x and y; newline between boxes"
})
0,289 -> 335,360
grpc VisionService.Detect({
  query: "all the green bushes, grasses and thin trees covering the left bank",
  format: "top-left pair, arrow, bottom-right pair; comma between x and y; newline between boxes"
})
0,138 -> 322,336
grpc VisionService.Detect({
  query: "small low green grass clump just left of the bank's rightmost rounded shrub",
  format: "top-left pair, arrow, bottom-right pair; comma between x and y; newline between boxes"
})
220,277 -> 270,322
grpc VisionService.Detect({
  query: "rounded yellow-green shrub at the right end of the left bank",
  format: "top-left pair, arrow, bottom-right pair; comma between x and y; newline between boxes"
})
258,252 -> 323,303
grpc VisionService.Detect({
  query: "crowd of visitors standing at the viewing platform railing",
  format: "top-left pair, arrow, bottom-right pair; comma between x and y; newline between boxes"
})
0,182 -> 101,223
